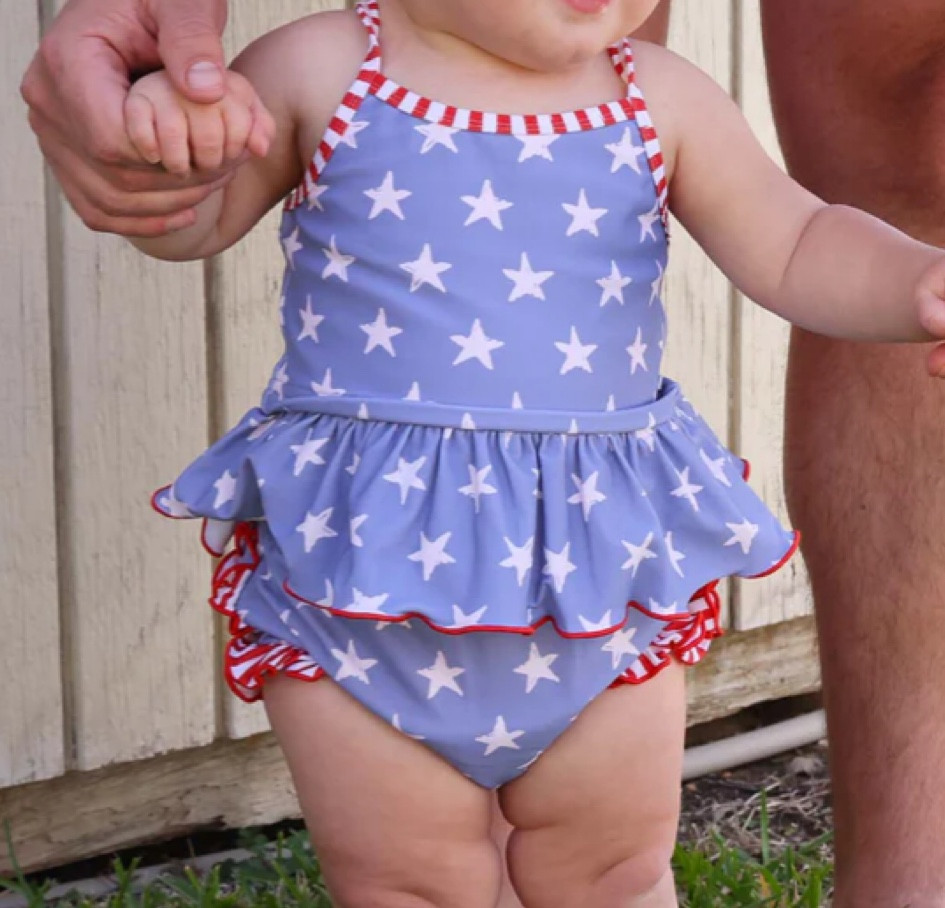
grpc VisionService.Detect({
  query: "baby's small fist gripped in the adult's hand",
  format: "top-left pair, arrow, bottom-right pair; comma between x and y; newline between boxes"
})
125,71 -> 276,176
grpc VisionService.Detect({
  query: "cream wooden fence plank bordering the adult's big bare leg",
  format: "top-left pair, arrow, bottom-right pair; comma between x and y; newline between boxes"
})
734,3 -> 812,630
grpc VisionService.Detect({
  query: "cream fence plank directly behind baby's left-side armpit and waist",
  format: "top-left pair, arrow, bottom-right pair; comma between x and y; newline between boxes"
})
216,0 -> 345,738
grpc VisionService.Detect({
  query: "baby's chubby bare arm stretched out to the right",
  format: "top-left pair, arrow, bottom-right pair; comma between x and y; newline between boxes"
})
637,45 -> 945,358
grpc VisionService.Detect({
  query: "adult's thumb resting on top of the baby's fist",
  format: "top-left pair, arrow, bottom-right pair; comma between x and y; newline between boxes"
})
151,0 -> 226,103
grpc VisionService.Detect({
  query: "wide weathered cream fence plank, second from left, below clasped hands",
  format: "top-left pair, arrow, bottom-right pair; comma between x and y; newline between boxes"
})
50,3 -> 216,769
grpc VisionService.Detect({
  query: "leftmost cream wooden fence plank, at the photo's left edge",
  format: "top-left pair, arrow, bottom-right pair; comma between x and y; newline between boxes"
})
0,0 -> 64,788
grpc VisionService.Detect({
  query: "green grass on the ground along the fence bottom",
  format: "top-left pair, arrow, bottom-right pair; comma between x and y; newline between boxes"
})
0,796 -> 832,908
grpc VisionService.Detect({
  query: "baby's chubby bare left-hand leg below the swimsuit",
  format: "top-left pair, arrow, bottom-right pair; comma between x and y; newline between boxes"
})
264,675 -> 501,908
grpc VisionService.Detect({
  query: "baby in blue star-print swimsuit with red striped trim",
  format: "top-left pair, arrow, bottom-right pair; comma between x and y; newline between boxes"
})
118,0 -> 945,908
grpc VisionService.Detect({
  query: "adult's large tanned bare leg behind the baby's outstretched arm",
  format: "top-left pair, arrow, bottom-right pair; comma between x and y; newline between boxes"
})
763,0 -> 945,908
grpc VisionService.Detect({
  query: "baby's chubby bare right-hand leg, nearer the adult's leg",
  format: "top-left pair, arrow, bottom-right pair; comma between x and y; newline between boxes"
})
499,664 -> 686,908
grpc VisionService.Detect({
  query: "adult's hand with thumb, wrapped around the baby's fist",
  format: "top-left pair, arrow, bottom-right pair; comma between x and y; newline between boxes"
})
21,0 -> 270,236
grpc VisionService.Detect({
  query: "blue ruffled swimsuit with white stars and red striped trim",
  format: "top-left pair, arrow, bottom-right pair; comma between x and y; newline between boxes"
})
154,2 -> 796,787
